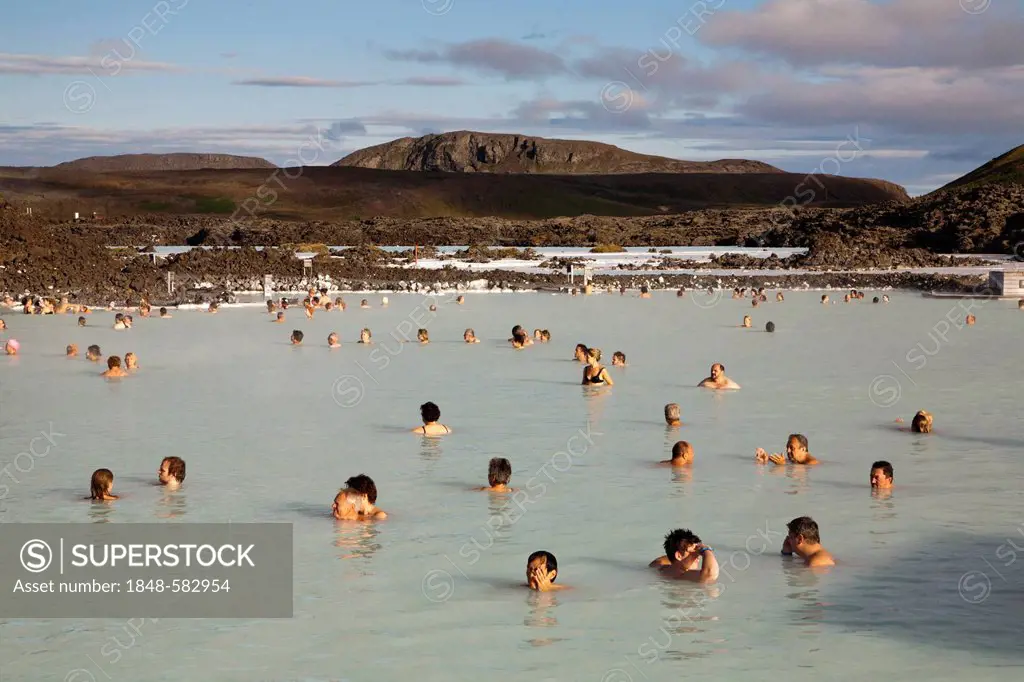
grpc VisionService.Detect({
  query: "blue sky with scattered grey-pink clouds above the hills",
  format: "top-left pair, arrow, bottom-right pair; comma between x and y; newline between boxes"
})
0,0 -> 1024,195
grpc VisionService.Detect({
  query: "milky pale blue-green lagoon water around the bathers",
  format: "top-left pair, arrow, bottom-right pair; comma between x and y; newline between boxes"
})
0,292 -> 1024,682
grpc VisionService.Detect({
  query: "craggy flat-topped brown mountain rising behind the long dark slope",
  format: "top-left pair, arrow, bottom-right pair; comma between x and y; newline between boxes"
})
333,130 -> 782,175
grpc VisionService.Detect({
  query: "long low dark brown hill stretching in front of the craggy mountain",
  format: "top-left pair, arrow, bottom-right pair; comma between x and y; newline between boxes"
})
0,166 -> 907,221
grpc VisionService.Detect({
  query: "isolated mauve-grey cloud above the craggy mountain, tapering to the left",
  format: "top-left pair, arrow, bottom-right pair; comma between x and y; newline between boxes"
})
384,38 -> 565,80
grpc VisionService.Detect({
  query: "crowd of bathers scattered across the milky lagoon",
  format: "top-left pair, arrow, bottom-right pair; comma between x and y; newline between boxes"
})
0,280 -> 995,592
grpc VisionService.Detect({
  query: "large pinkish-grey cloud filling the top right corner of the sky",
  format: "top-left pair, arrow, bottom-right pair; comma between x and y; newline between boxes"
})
696,0 -> 1024,69
